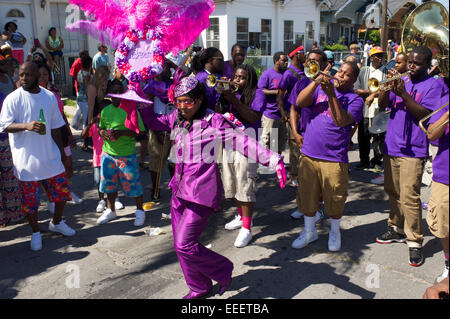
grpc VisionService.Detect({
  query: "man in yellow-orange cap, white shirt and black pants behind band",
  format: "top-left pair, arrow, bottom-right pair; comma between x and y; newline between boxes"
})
354,47 -> 386,171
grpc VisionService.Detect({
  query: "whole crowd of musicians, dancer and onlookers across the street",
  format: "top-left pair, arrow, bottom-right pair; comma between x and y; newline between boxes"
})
0,21 -> 449,298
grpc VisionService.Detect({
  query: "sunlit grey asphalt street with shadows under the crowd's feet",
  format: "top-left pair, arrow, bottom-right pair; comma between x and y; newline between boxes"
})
0,114 -> 444,299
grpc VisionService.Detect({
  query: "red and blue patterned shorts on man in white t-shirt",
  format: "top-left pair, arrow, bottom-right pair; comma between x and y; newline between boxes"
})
19,173 -> 72,215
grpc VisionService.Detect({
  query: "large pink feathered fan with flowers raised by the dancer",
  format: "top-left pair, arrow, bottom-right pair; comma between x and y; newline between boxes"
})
66,0 -> 215,132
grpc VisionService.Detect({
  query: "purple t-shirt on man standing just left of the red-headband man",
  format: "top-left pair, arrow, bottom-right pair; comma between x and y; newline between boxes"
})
252,68 -> 283,120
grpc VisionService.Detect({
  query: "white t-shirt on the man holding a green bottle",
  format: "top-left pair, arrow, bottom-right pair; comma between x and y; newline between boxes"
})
0,88 -> 65,182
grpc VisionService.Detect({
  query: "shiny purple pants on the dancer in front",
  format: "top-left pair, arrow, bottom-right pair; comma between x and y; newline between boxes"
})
171,196 -> 233,293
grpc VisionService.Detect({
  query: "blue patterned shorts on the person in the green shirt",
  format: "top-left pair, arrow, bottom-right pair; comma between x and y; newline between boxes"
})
99,153 -> 142,197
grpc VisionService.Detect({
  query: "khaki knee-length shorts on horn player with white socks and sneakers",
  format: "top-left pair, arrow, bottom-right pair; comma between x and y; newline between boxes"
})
297,155 -> 349,219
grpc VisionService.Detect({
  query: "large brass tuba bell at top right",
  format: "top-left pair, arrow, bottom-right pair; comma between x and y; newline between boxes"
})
401,1 -> 449,77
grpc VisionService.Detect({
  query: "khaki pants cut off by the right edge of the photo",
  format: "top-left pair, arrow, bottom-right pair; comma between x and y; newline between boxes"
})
427,181 -> 449,238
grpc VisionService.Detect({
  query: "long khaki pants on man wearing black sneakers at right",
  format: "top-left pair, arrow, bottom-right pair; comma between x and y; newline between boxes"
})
384,155 -> 423,247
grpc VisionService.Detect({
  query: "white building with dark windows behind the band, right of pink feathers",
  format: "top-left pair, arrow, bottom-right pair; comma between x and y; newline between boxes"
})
199,0 -> 321,59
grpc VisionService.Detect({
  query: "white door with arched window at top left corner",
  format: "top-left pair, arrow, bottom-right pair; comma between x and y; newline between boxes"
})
0,2 -> 33,59
